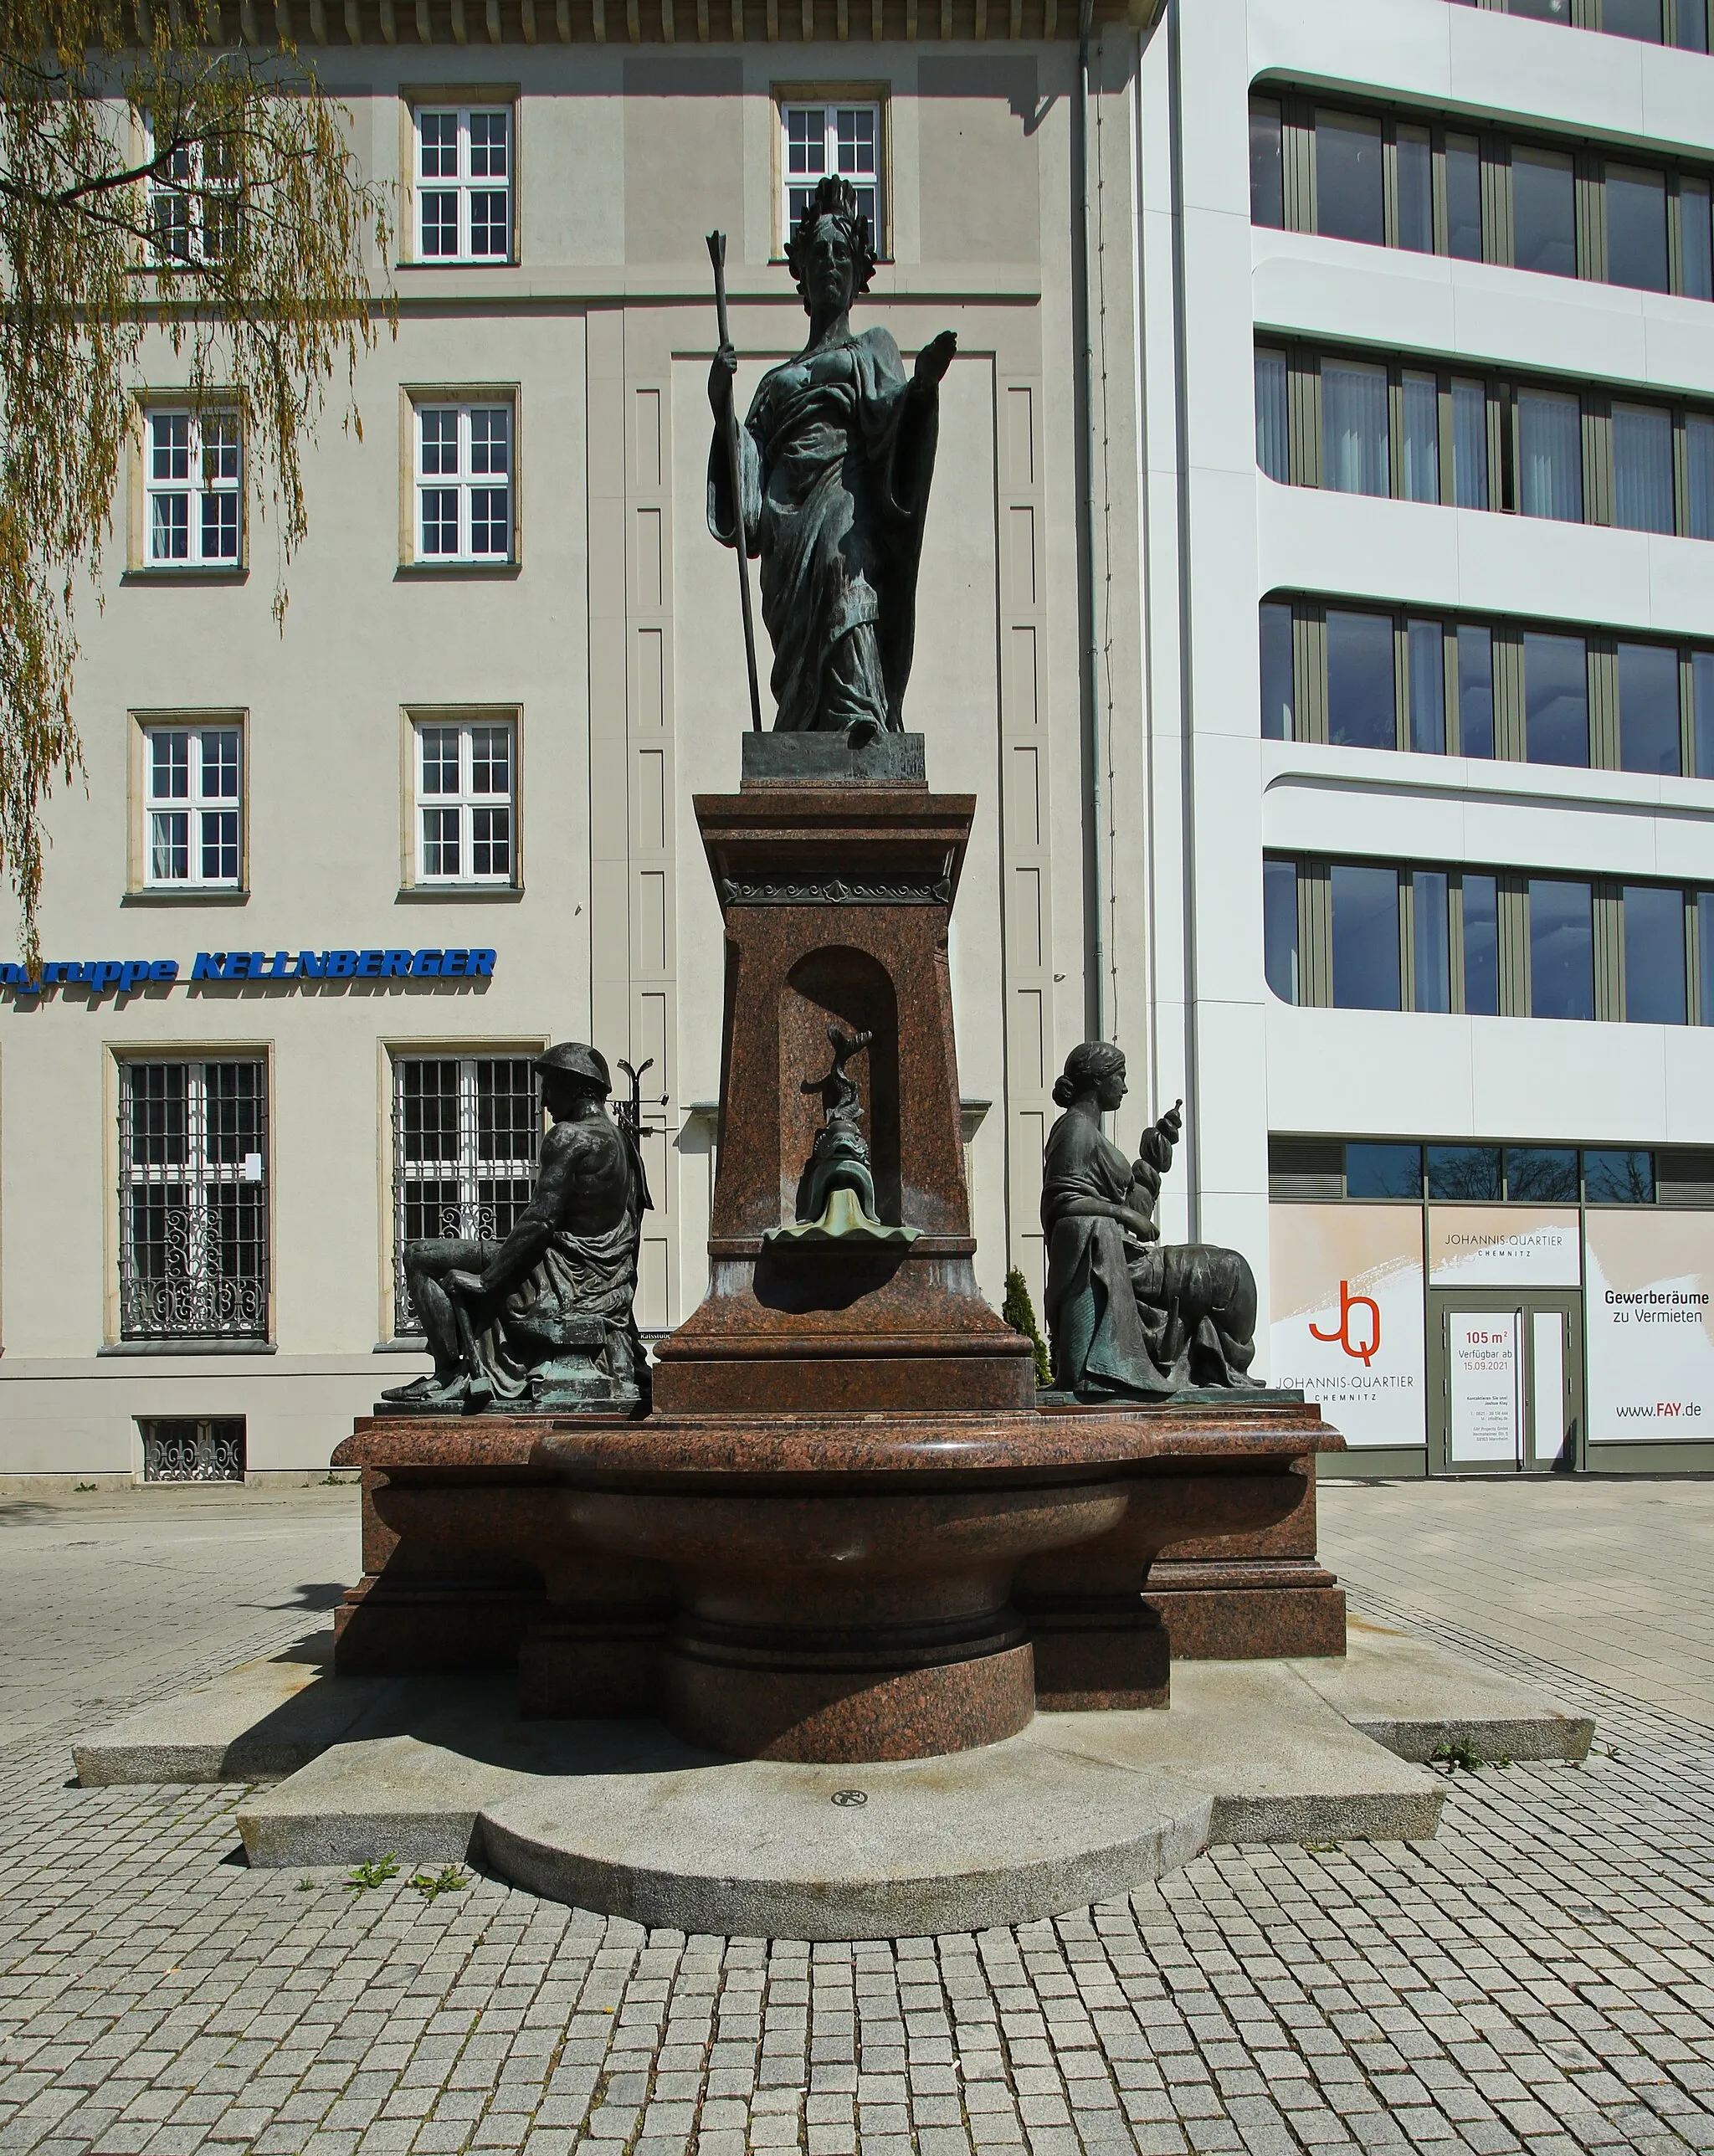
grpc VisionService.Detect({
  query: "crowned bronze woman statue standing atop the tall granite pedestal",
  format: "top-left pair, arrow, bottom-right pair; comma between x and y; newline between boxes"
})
707,177 -> 957,746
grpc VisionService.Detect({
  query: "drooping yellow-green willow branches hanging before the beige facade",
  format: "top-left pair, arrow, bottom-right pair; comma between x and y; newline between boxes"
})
0,0 -> 393,970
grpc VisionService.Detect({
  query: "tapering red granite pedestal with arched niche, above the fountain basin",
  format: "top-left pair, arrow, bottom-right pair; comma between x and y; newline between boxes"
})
655,778 -> 1035,1414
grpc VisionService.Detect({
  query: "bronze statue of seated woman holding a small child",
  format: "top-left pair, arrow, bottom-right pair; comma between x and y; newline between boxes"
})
1041,1041 -> 1259,1399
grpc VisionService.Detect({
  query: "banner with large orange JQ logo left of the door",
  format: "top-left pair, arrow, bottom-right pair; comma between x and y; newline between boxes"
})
1268,1205 -> 1427,1445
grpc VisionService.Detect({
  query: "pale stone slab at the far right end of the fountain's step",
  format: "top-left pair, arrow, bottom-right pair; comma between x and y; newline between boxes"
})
1311,1617 -> 1595,1759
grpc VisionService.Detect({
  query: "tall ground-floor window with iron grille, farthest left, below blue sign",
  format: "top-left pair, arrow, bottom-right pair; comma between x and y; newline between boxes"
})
119,1060 -> 267,1339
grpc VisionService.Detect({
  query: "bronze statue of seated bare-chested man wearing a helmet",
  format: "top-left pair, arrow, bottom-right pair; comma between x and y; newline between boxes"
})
382,1041 -> 651,1414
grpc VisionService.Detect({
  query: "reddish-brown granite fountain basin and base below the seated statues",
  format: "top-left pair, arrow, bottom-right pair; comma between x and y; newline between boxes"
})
334,1401 -> 1343,1762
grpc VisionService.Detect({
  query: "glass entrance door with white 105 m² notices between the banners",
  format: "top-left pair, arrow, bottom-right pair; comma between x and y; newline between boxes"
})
1429,1289 -> 1583,1475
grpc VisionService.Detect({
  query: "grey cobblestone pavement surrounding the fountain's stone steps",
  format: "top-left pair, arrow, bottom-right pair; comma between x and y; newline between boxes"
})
0,1492 -> 1714,2156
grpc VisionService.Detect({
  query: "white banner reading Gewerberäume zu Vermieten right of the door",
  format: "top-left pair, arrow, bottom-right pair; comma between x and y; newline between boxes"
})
1583,1212 -> 1714,1445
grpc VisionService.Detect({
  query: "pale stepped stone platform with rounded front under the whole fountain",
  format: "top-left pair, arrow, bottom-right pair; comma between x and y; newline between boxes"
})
74,1620 -> 1621,1940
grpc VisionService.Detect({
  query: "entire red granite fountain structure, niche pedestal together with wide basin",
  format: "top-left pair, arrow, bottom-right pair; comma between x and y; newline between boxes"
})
334,767 -> 1343,1762
